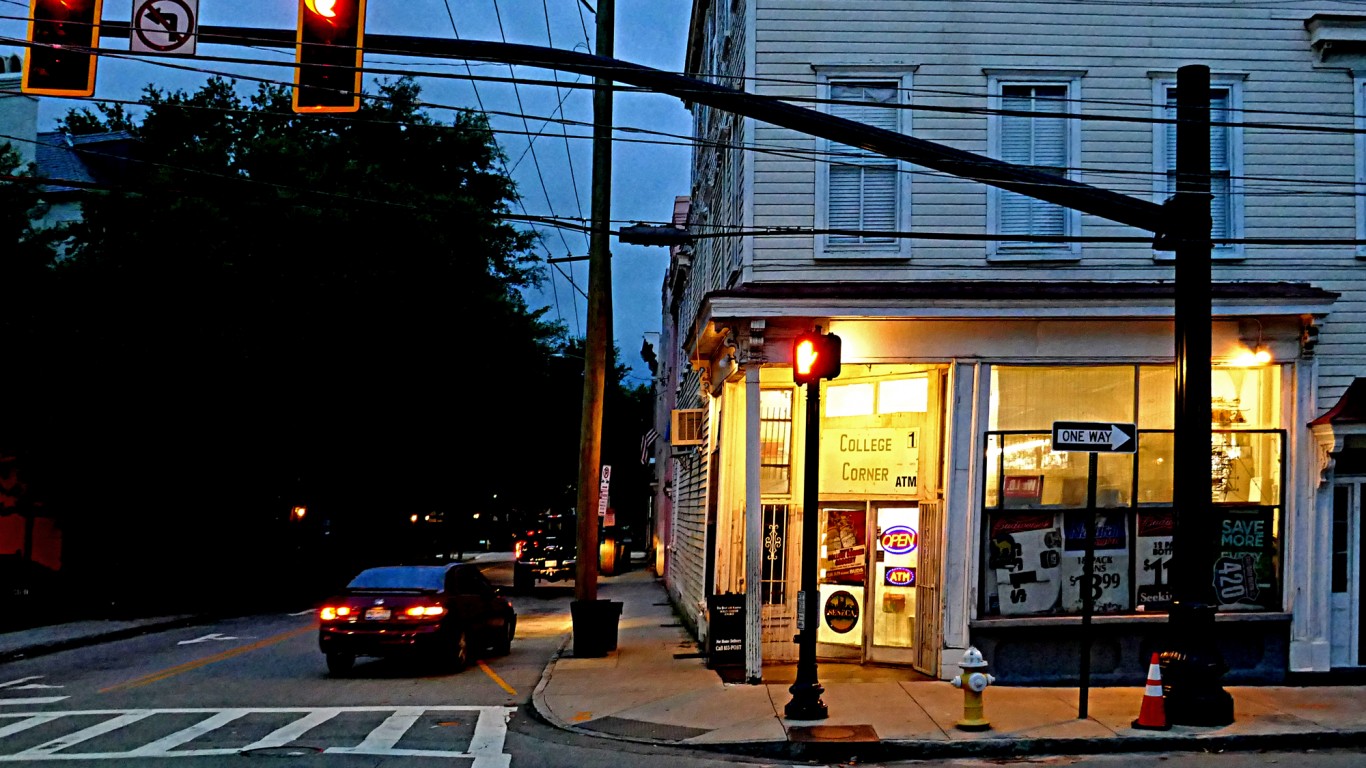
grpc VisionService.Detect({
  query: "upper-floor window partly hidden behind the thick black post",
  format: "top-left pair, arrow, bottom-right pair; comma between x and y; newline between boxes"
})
1154,79 -> 1243,258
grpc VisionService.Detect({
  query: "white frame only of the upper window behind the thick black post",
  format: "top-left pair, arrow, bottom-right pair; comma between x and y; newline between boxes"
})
1153,74 -> 1246,261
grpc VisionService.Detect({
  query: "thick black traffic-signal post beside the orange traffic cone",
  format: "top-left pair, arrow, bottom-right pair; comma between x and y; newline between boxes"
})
1161,64 -> 1233,726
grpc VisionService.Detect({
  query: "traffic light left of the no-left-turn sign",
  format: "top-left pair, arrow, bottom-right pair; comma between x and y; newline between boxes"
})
19,0 -> 104,96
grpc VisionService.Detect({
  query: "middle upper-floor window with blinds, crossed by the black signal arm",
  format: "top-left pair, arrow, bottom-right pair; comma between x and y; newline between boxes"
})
988,74 -> 1081,260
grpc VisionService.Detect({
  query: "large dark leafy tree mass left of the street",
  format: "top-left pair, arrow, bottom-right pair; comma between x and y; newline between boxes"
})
8,79 -> 603,609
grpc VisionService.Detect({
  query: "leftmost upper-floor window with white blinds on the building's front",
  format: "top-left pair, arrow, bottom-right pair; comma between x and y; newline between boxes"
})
817,77 -> 910,257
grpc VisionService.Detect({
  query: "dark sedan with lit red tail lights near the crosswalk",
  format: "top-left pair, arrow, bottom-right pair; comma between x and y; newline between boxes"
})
318,563 -> 516,675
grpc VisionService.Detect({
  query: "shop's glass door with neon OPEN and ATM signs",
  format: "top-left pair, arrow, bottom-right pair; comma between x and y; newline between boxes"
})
867,506 -> 933,663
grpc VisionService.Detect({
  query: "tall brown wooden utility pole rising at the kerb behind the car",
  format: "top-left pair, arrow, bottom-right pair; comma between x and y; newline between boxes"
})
574,0 -> 616,601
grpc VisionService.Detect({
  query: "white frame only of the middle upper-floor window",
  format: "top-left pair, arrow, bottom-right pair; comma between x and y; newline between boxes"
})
986,70 -> 1085,262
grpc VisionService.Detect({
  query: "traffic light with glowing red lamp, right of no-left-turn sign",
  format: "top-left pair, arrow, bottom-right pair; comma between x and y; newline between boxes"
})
294,0 -> 365,112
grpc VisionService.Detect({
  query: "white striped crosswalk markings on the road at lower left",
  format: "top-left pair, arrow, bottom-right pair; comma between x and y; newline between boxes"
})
0,707 -> 516,768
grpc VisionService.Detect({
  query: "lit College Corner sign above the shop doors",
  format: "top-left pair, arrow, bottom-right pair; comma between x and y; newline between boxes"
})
821,428 -> 921,496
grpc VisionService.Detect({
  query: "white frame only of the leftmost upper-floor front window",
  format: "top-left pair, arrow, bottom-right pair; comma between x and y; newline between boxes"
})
816,66 -> 914,260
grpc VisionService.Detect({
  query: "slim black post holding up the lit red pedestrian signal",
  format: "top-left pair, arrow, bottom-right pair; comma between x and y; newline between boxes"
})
783,374 -> 831,720
